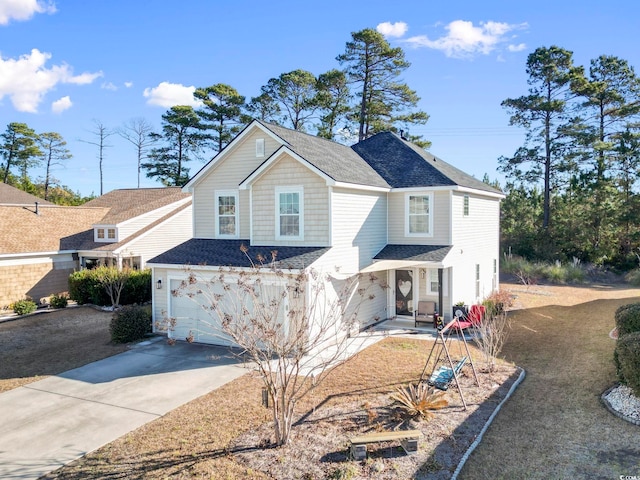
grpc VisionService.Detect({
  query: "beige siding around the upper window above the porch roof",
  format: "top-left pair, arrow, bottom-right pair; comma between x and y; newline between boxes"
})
389,190 -> 451,245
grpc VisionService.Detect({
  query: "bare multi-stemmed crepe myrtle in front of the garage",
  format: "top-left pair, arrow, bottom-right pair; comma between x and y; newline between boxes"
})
162,247 -> 388,446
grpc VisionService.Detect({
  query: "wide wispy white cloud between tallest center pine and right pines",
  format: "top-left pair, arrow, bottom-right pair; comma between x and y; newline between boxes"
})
406,20 -> 527,58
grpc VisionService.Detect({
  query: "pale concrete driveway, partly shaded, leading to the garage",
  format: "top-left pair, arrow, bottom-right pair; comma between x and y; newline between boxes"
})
0,337 -> 247,479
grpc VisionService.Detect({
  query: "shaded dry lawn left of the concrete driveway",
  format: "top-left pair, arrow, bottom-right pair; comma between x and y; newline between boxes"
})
0,307 -> 127,392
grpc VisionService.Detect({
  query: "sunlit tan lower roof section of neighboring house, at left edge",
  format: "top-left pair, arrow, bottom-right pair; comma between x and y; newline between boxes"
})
0,205 -> 108,254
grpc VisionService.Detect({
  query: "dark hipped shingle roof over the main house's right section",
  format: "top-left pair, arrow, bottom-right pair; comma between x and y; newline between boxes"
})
351,132 -> 502,194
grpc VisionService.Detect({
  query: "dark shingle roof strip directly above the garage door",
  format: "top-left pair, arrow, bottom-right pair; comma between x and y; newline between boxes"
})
147,238 -> 329,269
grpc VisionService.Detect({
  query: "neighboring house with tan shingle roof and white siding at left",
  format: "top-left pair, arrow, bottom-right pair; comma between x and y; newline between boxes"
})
0,184 -> 192,308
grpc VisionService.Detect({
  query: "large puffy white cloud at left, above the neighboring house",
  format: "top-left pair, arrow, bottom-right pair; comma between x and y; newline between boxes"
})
0,48 -> 102,113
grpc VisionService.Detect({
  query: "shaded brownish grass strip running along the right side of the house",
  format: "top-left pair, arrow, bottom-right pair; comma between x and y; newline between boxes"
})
460,289 -> 640,479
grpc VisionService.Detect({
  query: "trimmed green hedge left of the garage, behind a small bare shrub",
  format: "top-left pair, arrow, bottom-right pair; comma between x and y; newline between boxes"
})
69,267 -> 151,306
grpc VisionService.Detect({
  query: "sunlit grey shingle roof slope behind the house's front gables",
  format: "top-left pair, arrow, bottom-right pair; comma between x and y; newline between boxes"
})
250,122 -> 389,188
